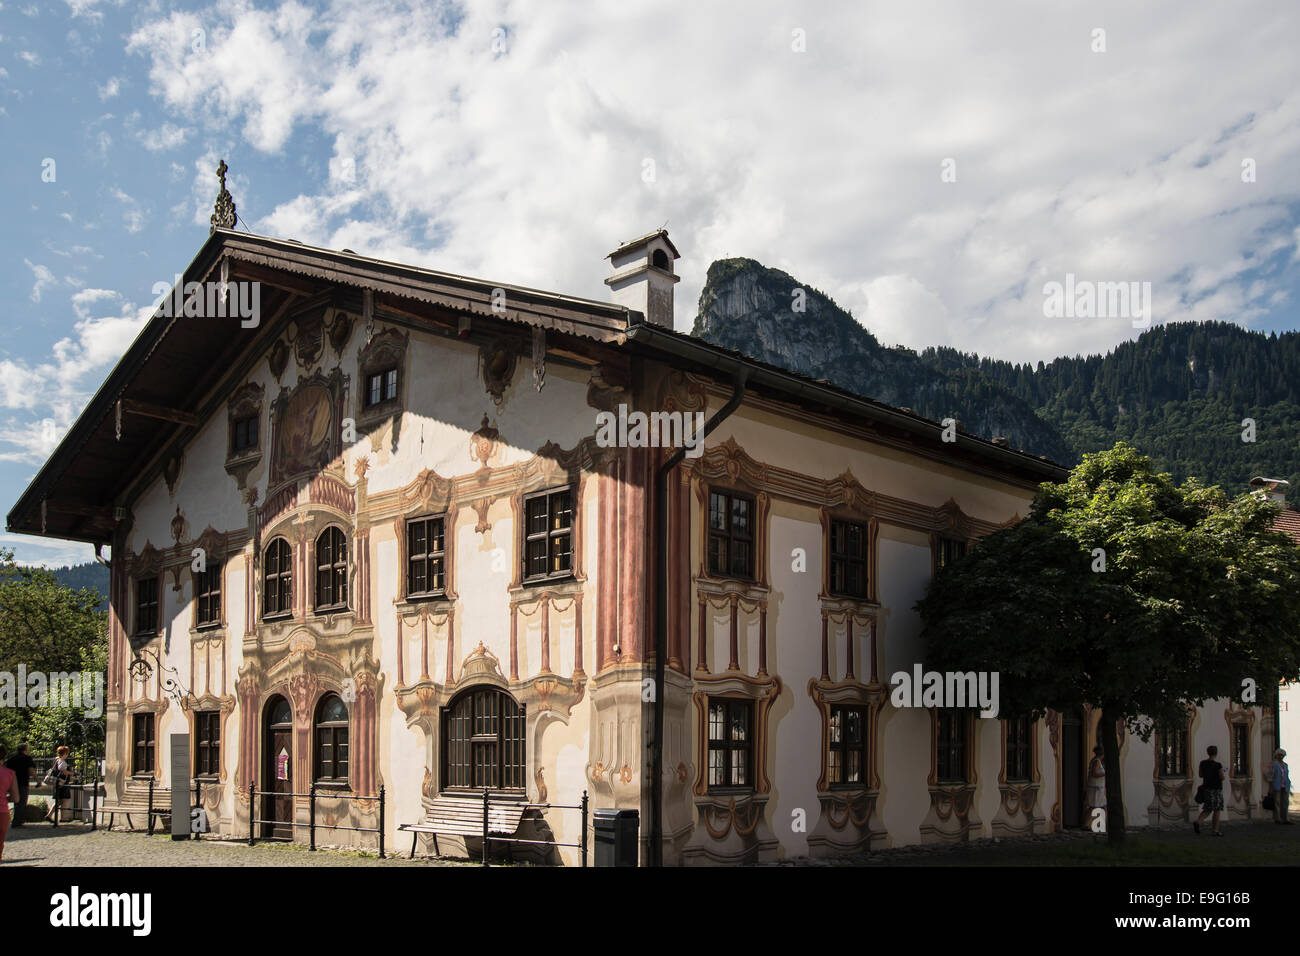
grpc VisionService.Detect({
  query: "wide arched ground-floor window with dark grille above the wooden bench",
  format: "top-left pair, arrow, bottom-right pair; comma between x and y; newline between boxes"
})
442,687 -> 525,791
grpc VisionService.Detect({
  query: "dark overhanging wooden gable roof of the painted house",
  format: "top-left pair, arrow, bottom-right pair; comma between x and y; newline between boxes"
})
8,229 -> 1066,544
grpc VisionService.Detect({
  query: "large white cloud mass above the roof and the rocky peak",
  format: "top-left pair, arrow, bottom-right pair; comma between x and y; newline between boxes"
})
111,0 -> 1300,359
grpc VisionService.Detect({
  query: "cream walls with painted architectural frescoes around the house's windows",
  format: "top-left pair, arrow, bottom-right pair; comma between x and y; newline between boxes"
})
107,295 -> 1262,864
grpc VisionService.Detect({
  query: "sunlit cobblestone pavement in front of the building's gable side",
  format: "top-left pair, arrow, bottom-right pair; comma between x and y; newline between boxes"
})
0,823 -> 478,866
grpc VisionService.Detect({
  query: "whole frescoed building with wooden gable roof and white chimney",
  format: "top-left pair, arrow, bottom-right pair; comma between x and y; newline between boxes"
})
9,221 -> 1273,864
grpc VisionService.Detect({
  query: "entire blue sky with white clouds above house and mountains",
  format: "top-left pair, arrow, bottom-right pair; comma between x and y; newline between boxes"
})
0,0 -> 1300,563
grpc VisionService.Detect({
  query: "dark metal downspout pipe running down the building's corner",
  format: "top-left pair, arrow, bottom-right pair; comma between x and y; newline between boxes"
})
650,365 -> 749,866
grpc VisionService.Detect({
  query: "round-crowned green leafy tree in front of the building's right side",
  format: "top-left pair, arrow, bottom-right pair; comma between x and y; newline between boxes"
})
918,442 -> 1300,844
